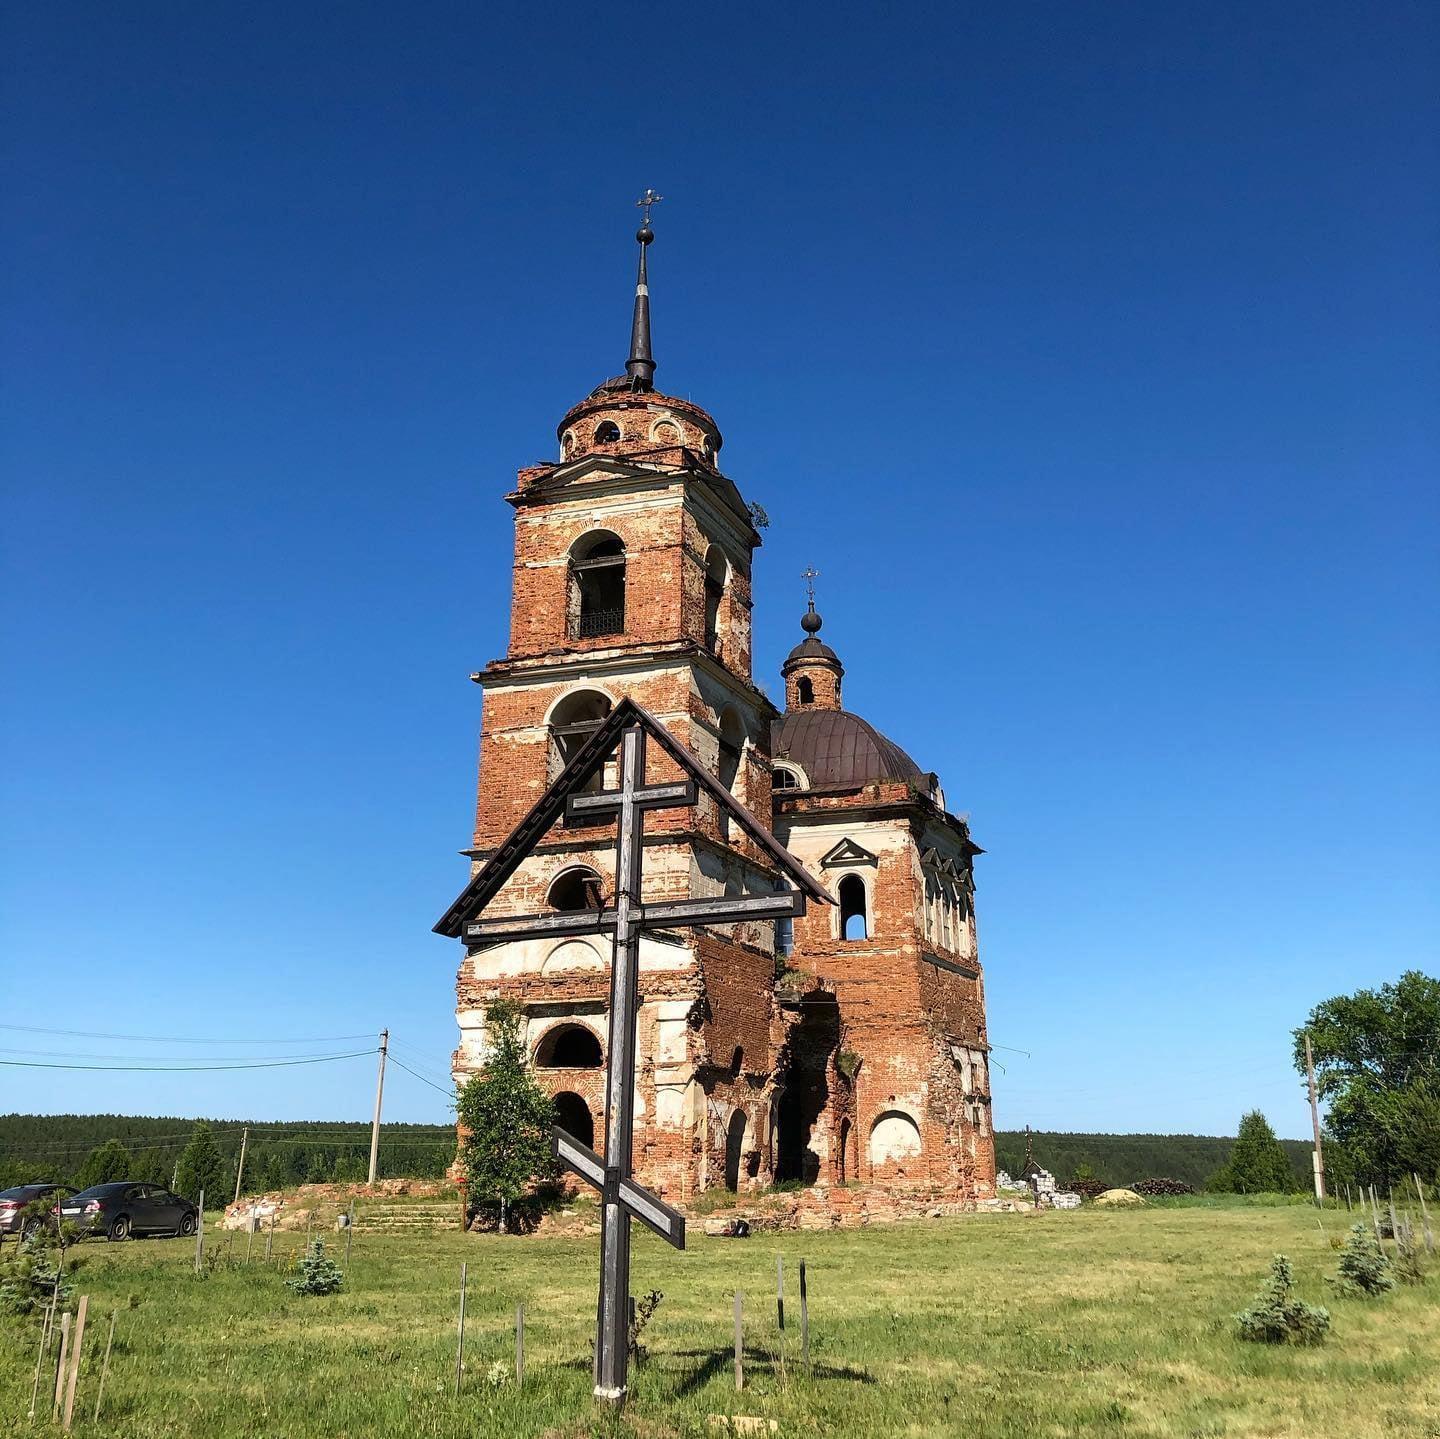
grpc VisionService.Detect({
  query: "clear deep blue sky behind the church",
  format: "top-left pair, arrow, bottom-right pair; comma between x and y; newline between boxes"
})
0,3 -> 1440,1135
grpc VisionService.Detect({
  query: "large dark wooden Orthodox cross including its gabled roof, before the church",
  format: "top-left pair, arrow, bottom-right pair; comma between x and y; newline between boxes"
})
435,700 -> 831,1403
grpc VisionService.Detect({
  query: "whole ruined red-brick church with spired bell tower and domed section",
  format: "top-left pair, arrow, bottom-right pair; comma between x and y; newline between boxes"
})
436,220 -> 995,1203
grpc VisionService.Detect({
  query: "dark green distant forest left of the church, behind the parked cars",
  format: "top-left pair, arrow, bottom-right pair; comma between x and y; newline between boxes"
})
0,1115 -> 455,1207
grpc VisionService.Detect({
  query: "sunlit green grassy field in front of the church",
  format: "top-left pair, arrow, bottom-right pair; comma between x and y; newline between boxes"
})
0,1206 -> 1440,1439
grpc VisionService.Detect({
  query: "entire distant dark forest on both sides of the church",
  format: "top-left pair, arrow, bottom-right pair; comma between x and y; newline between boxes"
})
0,1113 -> 1310,1193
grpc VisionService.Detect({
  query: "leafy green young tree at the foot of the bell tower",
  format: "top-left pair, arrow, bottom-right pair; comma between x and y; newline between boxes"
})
456,1000 -> 556,1234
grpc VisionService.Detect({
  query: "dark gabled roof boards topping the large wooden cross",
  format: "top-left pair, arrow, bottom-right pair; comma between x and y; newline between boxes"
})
435,696 -> 835,939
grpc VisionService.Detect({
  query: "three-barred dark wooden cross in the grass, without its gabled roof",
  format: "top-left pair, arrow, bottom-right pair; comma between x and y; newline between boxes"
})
461,714 -> 828,1403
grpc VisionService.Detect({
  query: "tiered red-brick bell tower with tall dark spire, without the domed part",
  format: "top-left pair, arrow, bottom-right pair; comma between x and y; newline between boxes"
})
455,192 -> 779,1193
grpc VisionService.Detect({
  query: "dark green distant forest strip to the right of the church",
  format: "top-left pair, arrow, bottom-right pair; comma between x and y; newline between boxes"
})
995,1129 -> 1310,1190
